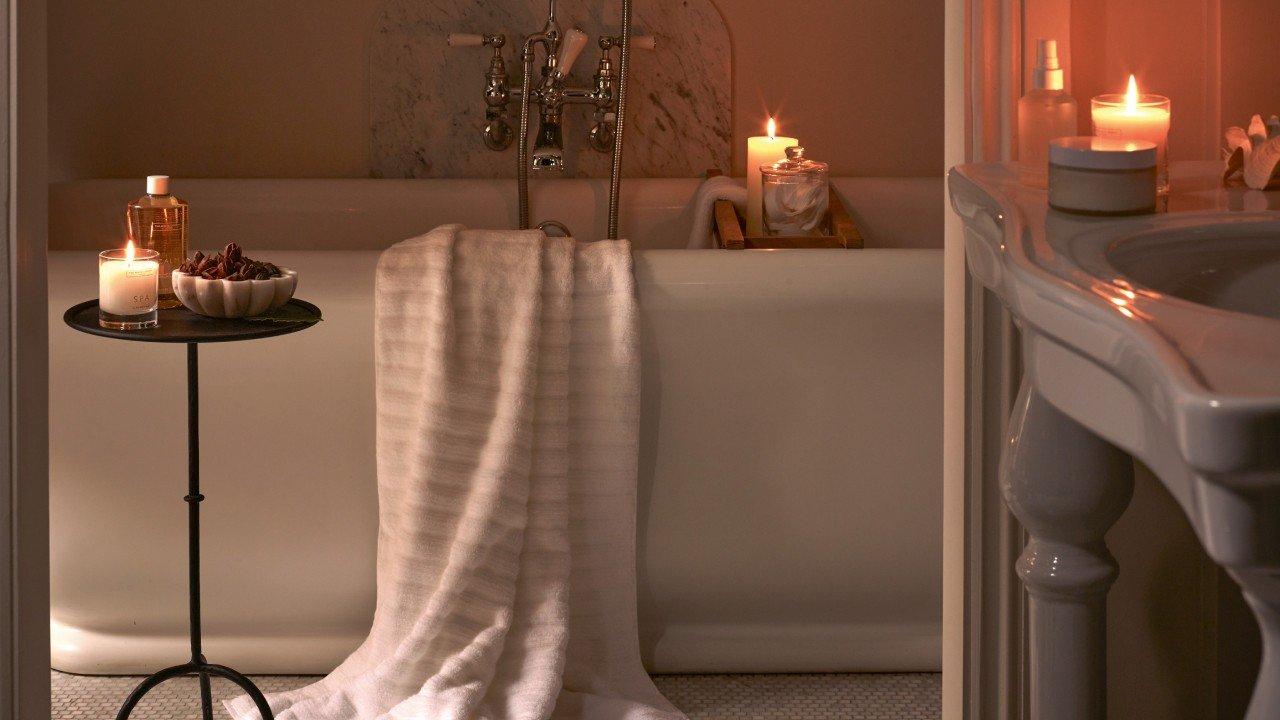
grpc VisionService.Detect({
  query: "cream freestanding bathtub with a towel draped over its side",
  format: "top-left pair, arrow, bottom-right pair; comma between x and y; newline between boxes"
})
49,178 -> 943,674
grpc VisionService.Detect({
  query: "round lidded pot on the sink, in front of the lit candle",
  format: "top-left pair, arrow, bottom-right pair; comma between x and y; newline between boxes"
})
1048,136 -> 1156,217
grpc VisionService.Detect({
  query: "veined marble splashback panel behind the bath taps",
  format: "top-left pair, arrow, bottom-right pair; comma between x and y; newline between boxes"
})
370,0 -> 732,178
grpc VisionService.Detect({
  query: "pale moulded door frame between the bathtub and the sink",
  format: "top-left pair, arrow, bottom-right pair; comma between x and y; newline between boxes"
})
942,0 -> 1029,720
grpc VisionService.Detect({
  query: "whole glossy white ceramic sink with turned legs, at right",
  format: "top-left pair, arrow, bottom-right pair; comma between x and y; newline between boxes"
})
950,163 -> 1280,720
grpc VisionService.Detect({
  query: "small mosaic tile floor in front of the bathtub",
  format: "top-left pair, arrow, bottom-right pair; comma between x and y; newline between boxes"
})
52,671 -> 942,720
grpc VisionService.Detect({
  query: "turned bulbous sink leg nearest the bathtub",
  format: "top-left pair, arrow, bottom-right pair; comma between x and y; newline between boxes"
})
1001,378 -> 1133,720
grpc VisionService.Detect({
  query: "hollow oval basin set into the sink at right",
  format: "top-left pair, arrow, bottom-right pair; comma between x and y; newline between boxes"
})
1106,227 -> 1280,319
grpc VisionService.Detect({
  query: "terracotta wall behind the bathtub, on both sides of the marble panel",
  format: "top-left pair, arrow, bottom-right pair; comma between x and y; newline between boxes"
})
49,0 -> 943,181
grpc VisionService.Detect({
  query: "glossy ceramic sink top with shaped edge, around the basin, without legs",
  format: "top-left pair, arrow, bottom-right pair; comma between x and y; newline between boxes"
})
948,163 -> 1280,469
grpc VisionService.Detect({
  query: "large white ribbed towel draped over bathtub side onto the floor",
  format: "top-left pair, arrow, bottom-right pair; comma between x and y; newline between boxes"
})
234,225 -> 684,720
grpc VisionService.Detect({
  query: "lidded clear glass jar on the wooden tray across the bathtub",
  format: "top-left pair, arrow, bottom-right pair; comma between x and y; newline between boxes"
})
760,146 -> 829,236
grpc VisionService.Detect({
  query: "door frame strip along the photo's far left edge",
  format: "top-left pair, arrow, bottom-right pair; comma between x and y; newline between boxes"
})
0,0 -> 50,720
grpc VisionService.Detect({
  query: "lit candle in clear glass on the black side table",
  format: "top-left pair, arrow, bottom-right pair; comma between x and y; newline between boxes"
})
97,240 -> 160,331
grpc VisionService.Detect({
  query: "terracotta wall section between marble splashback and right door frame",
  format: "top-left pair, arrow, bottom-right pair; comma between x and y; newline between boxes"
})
714,0 -> 943,176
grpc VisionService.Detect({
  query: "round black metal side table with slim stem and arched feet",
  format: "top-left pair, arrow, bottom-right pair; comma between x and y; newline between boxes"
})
63,300 -> 320,720
